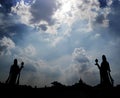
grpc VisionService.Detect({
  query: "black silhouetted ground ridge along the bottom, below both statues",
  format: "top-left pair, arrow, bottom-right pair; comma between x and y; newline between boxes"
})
0,81 -> 120,98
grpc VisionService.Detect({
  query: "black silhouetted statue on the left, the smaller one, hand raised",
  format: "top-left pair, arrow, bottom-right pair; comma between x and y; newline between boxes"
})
6,59 -> 24,85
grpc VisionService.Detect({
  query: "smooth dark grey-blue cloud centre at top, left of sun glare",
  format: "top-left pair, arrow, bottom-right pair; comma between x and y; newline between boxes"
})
30,0 -> 57,24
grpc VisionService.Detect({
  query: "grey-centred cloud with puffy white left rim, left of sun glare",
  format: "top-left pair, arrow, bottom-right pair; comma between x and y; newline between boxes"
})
11,0 -> 56,30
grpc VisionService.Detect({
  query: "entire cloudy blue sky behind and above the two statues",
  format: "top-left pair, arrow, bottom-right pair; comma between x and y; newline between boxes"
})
0,0 -> 120,87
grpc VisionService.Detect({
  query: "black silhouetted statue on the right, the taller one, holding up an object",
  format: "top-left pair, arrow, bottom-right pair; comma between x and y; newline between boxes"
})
95,55 -> 114,86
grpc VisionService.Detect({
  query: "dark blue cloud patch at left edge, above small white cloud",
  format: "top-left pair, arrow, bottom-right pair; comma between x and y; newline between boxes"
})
0,16 -> 29,42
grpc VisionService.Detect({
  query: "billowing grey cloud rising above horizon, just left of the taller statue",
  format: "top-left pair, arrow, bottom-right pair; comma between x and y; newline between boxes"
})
54,48 -> 95,85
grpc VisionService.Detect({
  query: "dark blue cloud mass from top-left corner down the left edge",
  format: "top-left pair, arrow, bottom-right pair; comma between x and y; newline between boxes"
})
0,0 -> 32,42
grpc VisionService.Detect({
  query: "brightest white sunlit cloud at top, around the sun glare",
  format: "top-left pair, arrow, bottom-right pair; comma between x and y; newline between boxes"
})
53,0 -> 99,32
